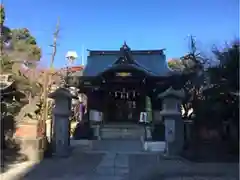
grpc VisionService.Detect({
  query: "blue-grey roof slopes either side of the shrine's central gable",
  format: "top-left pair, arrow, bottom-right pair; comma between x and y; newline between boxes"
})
83,50 -> 172,76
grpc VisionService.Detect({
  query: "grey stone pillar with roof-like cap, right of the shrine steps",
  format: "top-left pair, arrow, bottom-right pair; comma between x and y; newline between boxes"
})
158,87 -> 184,155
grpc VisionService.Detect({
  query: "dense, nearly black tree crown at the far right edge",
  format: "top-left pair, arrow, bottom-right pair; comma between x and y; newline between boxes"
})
205,41 -> 240,124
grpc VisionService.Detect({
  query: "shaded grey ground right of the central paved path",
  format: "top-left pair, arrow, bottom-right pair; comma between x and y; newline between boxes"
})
129,155 -> 239,180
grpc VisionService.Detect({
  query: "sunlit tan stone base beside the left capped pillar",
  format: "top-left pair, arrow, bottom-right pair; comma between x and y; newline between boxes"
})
15,118 -> 47,162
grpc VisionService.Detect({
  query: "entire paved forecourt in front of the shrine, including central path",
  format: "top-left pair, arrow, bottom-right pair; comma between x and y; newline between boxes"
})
1,141 -> 238,180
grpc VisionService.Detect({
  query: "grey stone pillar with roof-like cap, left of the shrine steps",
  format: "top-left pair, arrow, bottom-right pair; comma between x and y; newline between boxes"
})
49,88 -> 74,157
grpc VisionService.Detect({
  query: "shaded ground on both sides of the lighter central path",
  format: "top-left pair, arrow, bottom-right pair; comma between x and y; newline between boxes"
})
3,148 -> 238,180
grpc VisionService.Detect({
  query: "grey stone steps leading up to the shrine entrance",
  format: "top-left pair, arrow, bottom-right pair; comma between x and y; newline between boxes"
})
100,124 -> 145,140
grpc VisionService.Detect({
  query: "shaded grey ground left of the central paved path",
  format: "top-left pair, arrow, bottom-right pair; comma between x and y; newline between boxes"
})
22,153 -> 103,180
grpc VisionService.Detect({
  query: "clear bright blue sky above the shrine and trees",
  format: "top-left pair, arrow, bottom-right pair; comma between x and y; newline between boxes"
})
2,0 -> 239,67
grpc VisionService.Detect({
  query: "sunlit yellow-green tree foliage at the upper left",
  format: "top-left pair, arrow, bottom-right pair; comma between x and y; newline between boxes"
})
1,27 -> 41,94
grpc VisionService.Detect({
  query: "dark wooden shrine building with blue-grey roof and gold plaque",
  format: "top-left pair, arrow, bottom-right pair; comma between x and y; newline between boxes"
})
69,43 -> 184,124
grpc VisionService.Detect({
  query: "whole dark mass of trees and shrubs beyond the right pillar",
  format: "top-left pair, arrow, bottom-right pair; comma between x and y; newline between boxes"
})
170,38 -> 240,157
